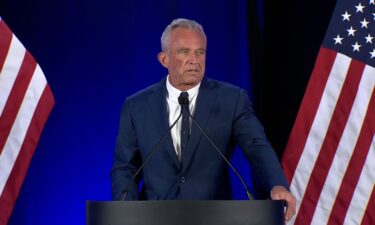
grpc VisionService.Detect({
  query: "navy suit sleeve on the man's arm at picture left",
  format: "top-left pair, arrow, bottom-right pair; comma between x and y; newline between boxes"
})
111,99 -> 141,200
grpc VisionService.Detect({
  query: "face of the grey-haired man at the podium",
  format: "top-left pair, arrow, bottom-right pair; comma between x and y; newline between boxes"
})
159,28 -> 207,90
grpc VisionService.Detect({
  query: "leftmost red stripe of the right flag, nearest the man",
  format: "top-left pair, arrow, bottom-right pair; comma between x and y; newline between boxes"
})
282,48 -> 336,182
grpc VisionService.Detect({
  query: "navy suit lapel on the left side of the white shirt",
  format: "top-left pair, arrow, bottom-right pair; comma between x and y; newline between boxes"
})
148,79 -> 180,167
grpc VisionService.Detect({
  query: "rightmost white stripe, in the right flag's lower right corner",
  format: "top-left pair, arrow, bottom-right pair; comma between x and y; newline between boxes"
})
344,136 -> 375,224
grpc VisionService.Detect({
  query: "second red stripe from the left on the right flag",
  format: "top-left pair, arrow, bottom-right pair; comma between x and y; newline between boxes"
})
296,60 -> 365,224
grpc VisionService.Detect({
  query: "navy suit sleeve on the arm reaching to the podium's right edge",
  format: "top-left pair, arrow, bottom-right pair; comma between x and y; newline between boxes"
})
233,90 -> 289,193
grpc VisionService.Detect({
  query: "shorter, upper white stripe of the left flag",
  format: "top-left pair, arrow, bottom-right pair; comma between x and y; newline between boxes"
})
0,35 -> 26,116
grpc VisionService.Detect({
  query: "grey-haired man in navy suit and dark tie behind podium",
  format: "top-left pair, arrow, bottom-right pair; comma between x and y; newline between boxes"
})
112,19 -> 295,220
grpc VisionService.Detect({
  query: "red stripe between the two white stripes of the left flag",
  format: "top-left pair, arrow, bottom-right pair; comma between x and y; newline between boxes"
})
0,51 -> 36,154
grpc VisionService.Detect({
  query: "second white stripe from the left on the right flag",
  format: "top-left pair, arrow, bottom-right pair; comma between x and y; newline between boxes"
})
311,66 -> 375,224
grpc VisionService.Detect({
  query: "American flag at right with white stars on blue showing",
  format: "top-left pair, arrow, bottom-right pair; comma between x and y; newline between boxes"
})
282,0 -> 375,225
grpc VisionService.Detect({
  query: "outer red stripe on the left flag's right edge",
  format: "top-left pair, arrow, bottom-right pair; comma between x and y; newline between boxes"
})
0,85 -> 54,225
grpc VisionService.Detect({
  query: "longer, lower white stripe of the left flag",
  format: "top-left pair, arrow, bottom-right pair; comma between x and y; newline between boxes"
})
0,65 -> 47,194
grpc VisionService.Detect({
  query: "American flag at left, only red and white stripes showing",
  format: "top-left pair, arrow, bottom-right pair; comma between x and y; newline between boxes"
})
0,18 -> 54,225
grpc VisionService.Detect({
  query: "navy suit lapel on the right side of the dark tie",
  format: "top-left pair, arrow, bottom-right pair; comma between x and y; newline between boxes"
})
183,78 -> 216,170
